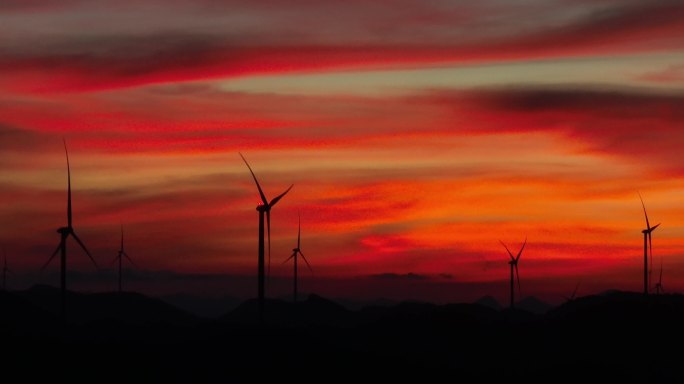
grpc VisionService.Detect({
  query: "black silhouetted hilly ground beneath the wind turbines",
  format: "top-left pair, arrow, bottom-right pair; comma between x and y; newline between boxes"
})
0,287 -> 684,383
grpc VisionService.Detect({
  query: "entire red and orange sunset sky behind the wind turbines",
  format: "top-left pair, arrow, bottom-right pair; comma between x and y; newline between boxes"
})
0,0 -> 684,301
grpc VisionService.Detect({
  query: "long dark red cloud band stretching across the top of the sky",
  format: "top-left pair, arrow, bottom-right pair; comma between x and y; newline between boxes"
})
0,2 -> 684,93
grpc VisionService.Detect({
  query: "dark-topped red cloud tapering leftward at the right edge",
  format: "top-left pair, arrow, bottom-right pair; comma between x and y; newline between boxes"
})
425,88 -> 684,175
